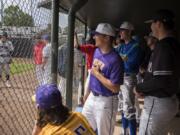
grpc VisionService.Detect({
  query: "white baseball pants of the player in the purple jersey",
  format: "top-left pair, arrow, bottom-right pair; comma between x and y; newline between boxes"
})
82,92 -> 118,135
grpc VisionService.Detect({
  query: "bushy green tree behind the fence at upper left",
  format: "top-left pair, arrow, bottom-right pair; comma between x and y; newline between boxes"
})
3,5 -> 34,27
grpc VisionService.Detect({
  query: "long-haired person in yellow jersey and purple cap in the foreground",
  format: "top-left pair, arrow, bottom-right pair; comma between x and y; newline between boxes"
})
32,84 -> 95,135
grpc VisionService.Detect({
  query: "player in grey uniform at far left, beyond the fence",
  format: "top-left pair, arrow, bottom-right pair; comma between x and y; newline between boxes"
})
0,32 -> 14,87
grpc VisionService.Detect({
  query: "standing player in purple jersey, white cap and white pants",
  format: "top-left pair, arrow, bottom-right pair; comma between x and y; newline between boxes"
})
82,23 -> 123,135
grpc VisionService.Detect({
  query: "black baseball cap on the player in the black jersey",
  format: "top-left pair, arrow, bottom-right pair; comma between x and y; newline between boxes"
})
145,9 -> 174,23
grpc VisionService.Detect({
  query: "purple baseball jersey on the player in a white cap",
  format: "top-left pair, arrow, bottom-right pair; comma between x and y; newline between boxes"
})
89,48 -> 124,96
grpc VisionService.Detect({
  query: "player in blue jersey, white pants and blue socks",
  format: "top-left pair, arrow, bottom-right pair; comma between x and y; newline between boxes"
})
116,22 -> 141,135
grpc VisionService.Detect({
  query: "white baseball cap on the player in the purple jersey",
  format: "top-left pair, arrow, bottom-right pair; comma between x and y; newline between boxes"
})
95,23 -> 115,37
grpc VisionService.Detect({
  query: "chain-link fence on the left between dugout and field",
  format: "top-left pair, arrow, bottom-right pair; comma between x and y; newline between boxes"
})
0,0 -> 82,135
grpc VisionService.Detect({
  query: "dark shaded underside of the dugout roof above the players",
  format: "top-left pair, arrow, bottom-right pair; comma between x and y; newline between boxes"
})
39,0 -> 180,33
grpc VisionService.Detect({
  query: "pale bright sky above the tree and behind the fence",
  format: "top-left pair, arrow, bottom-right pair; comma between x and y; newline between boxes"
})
0,0 -> 67,28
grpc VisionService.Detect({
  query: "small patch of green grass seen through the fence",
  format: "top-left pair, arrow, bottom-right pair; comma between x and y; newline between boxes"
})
10,61 -> 34,75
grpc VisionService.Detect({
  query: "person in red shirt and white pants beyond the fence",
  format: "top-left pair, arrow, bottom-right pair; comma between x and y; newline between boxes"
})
33,37 -> 45,85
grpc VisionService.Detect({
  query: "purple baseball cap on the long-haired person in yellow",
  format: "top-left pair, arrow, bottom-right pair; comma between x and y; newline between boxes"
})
35,84 -> 62,109
